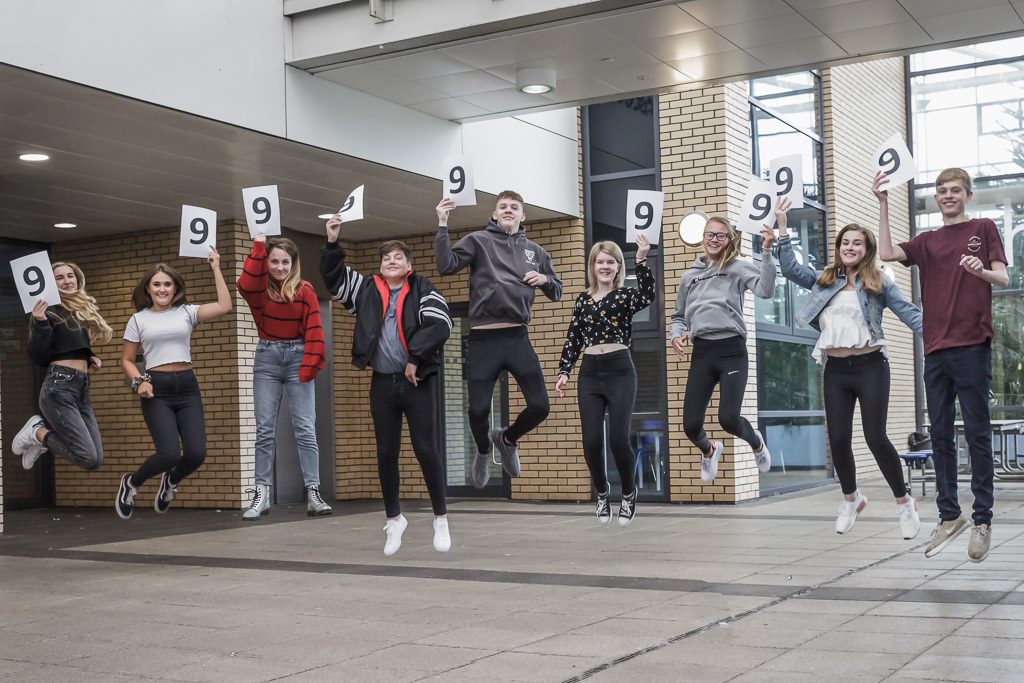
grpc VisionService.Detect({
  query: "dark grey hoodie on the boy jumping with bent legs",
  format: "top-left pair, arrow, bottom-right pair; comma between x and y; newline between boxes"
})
434,220 -> 562,327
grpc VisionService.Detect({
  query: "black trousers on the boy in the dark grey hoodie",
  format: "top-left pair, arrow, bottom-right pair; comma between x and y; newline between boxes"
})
466,326 -> 551,453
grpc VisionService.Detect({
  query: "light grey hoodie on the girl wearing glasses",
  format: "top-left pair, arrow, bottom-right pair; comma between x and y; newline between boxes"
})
669,252 -> 775,340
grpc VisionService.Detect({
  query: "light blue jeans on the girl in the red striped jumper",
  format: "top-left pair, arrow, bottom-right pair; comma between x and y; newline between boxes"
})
253,339 -> 319,487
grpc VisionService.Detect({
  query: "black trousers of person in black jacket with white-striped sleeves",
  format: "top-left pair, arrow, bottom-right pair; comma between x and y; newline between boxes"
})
370,373 -> 447,517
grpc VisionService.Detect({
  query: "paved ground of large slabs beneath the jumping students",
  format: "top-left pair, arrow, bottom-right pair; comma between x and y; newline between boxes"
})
0,484 -> 1024,683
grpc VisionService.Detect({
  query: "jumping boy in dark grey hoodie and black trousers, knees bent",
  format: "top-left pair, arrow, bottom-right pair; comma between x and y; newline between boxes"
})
434,189 -> 562,488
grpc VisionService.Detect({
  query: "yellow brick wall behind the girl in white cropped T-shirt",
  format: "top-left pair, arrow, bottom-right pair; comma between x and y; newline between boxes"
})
51,221 -> 256,509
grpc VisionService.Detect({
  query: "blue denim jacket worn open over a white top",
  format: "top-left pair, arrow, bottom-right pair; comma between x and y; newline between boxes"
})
778,237 -> 921,339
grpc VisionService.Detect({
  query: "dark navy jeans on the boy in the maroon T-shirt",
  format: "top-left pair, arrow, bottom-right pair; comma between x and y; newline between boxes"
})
925,343 -> 994,524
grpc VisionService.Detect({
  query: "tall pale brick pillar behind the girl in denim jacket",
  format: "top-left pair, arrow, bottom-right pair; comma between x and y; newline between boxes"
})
822,57 -> 915,479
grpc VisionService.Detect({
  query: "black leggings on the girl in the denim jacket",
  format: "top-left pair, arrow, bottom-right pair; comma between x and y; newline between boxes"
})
824,351 -> 907,498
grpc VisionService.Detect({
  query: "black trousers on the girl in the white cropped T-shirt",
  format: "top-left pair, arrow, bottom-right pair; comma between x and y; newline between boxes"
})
130,370 -> 206,488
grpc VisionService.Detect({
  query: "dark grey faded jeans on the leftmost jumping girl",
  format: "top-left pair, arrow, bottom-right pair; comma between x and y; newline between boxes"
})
39,366 -> 103,470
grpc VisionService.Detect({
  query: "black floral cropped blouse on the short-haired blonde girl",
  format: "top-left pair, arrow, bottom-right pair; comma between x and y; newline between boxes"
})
558,263 -> 654,375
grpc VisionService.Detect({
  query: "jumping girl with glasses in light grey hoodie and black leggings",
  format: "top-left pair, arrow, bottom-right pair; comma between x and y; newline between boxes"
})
669,217 -> 775,482
